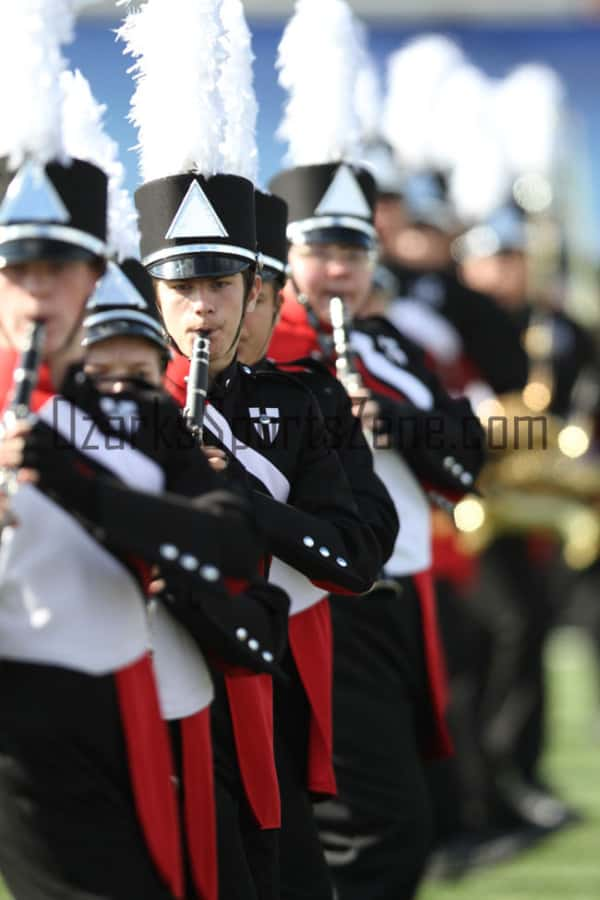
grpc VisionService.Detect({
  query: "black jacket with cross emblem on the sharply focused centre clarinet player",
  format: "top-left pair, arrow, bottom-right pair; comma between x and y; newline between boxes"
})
166,357 -> 382,593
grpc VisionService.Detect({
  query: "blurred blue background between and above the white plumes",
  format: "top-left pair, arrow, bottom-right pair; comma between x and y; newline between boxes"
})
79,0 -> 600,251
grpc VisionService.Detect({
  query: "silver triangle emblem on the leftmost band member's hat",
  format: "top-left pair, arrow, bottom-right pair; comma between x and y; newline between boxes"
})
0,159 -> 71,225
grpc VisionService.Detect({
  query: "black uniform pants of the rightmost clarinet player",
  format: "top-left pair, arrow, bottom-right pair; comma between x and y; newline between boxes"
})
316,578 -> 433,900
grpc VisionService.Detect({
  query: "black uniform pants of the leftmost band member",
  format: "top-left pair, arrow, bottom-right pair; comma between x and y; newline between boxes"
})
0,661 -> 172,900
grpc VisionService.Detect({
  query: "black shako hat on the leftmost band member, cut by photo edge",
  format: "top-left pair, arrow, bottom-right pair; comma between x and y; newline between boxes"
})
0,157 -> 108,268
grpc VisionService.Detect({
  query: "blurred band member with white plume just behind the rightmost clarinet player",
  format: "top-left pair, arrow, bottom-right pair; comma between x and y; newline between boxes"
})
372,34 -> 526,403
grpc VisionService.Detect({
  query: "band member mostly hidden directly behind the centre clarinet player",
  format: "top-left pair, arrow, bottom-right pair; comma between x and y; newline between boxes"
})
239,185 -> 398,892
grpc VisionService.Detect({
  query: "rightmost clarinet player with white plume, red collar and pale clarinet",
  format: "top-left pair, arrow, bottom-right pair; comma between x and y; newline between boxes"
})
268,3 -> 482,900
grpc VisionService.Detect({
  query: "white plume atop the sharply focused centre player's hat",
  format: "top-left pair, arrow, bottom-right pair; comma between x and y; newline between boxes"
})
119,0 -> 223,181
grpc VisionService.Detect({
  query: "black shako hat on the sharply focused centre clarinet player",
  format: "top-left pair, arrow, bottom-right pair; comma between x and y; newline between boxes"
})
135,172 -> 256,279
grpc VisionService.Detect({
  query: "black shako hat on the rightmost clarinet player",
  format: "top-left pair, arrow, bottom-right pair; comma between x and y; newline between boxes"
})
269,162 -> 376,247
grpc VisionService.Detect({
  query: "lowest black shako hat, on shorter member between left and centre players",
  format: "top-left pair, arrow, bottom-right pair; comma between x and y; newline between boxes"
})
82,259 -> 169,355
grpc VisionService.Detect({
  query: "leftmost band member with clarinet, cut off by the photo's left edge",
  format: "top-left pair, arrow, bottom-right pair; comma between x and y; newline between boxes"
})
0,2 -> 184,900
